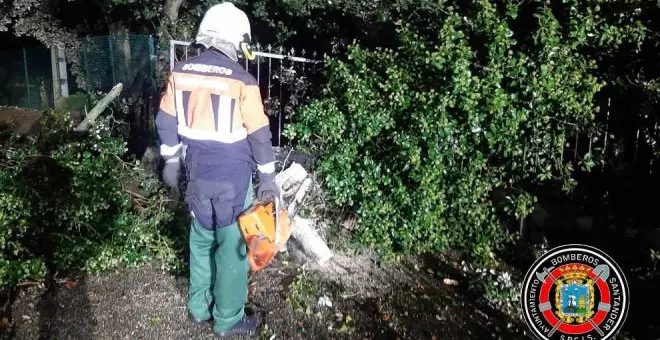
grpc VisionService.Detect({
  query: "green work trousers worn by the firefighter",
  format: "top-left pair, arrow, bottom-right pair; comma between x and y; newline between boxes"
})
188,185 -> 252,332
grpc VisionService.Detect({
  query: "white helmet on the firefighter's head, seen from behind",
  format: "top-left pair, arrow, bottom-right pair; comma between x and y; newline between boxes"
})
195,2 -> 254,60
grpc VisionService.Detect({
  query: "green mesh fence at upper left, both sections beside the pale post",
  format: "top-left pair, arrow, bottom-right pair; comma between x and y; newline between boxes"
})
0,35 -> 158,110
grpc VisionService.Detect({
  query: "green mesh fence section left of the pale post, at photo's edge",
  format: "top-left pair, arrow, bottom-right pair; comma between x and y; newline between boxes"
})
0,47 -> 53,110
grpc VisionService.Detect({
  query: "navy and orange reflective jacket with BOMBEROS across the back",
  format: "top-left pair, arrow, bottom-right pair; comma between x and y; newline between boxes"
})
156,49 -> 275,228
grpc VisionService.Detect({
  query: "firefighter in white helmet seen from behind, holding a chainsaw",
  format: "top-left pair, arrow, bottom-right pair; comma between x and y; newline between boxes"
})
156,2 -> 280,337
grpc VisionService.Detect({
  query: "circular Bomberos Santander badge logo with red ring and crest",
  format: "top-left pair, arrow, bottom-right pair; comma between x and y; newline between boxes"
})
521,244 -> 630,340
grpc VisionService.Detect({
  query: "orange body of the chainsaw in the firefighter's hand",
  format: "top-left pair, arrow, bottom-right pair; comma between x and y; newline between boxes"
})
238,201 -> 293,272
